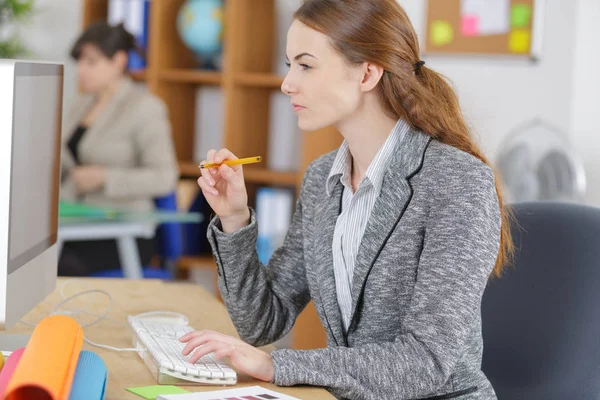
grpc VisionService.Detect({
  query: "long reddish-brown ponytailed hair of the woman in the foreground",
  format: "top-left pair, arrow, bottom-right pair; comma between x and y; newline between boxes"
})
294,0 -> 514,276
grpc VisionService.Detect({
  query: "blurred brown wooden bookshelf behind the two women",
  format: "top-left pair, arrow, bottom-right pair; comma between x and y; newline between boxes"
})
82,0 -> 341,349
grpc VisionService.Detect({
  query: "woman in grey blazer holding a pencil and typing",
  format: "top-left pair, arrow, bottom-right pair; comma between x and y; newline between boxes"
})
181,0 -> 512,400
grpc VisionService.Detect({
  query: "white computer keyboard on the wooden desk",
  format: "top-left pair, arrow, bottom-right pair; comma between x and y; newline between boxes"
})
128,317 -> 237,385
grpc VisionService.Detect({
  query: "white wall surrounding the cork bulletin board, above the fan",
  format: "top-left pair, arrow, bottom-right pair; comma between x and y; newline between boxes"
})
399,0 -> 576,160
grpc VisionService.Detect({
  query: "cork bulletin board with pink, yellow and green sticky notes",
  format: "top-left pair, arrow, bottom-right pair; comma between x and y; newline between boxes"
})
424,0 -> 545,59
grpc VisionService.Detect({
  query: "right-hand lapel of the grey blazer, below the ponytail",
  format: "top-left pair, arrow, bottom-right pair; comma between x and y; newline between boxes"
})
346,130 -> 431,332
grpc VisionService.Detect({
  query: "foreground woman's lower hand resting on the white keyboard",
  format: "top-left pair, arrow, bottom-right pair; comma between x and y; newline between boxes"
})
179,331 -> 275,382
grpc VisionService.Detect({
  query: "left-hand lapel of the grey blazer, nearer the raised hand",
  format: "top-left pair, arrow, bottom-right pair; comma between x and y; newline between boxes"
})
314,178 -> 346,346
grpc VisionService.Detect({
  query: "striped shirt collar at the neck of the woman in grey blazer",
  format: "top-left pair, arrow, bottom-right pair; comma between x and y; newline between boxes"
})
326,119 -> 410,196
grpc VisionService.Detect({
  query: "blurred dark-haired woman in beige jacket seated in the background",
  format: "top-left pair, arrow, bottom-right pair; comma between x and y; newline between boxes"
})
59,23 -> 178,276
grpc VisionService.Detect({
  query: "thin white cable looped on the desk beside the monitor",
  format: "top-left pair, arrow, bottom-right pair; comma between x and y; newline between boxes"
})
20,278 -> 146,352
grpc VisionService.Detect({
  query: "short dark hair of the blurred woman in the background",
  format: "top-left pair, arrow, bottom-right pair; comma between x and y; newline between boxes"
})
71,22 -> 144,60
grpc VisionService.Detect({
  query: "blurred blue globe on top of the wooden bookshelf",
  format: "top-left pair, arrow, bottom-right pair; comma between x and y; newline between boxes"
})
177,0 -> 223,67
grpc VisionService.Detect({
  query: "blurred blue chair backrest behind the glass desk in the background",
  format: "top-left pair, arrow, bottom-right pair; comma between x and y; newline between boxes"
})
154,192 -> 183,261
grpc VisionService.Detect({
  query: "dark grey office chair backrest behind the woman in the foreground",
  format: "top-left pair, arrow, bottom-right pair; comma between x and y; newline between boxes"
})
482,202 -> 600,400
